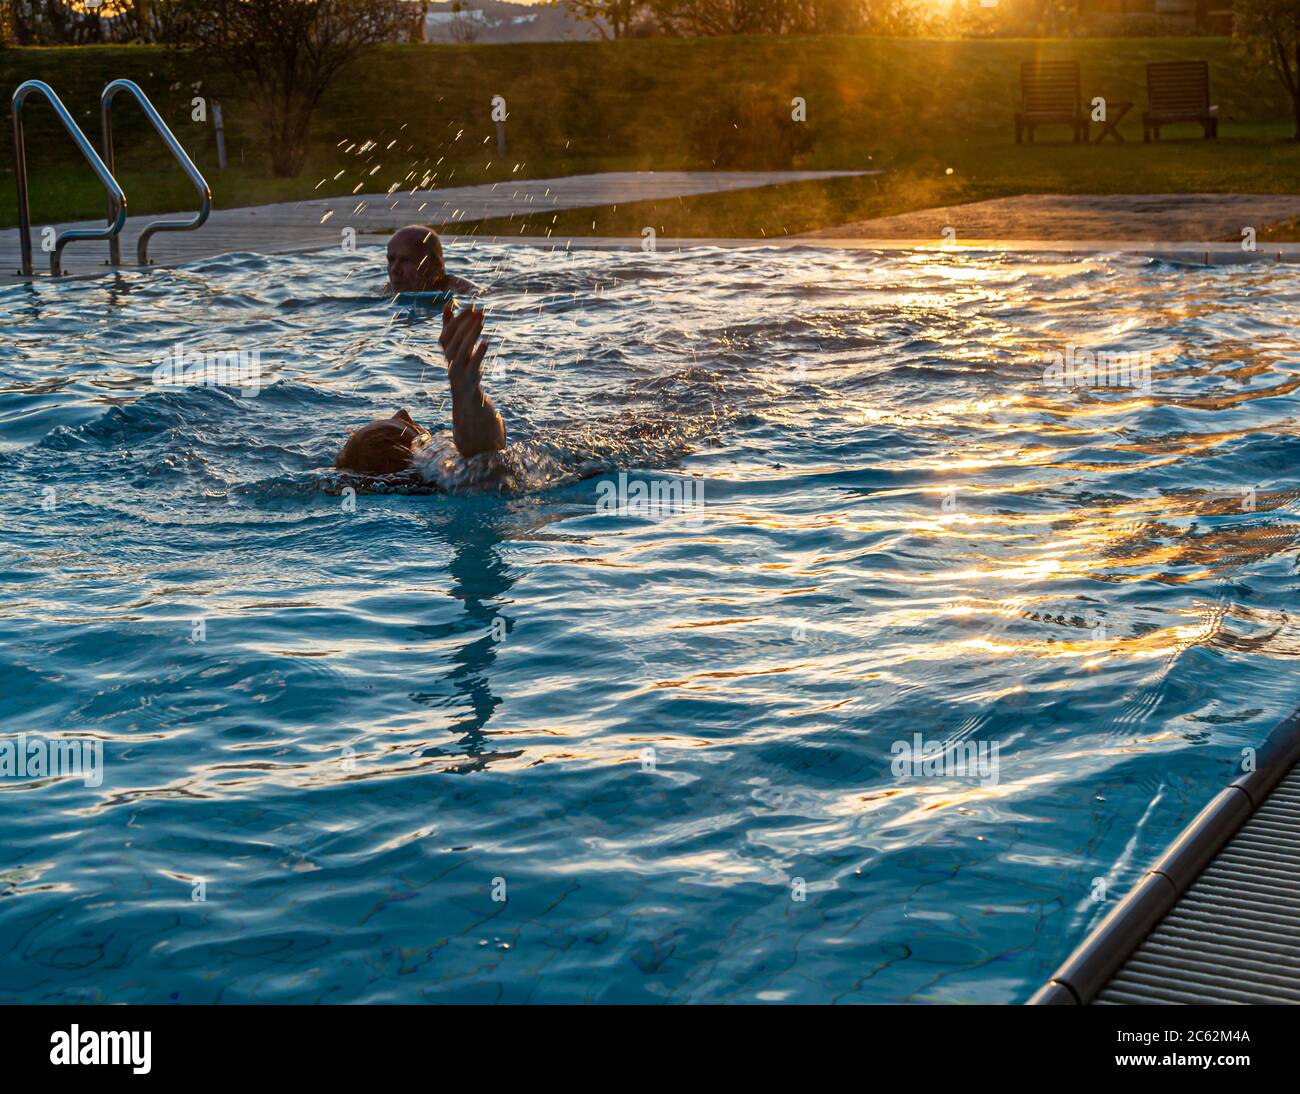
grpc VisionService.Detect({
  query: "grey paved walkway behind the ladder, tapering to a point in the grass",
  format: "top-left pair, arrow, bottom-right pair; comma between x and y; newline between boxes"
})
0,172 -> 879,281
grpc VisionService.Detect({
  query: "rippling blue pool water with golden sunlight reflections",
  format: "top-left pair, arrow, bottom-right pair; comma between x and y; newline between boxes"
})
0,242 -> 1300,1003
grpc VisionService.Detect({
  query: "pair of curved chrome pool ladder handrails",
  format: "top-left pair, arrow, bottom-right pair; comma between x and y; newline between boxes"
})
12,79 -> 212,277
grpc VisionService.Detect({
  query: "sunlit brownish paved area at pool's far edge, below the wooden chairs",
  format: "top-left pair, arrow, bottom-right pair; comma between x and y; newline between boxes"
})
801,194 -> 1300,243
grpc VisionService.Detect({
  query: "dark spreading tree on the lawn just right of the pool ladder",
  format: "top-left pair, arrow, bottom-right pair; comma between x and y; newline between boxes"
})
174,0 -> 410,178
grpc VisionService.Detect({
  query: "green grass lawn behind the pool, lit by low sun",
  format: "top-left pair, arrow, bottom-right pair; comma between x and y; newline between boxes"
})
0,38 -> 1300,236
